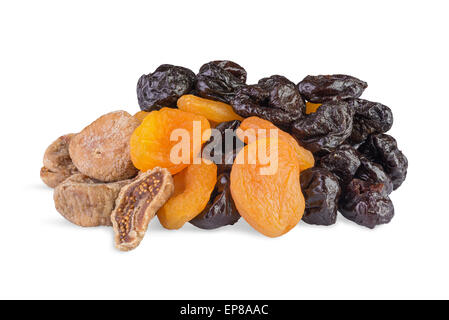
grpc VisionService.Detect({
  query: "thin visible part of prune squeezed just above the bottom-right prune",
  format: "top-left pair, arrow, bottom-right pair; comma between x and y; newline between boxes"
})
354,155 -> 393,195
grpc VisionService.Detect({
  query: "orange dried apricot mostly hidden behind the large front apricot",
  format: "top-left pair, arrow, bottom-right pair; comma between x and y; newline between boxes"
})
236,117 -> 315,171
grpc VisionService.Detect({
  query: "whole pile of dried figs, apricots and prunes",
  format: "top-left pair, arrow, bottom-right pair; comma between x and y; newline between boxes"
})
41,60 -> 408,251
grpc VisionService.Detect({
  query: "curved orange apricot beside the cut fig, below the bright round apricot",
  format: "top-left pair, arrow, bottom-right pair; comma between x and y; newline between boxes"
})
157,161 -> 217,229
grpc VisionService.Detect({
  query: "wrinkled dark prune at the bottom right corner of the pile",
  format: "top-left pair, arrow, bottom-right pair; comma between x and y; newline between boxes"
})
339,179 -> 394,229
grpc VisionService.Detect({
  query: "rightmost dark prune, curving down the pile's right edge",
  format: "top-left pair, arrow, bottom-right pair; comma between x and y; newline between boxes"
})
358,133 -> 408,190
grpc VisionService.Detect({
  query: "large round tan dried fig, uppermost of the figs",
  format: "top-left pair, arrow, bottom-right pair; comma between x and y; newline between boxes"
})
69,111 -> 139,182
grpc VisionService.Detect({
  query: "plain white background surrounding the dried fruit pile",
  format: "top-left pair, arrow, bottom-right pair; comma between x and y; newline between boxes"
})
0,0 -> 449,299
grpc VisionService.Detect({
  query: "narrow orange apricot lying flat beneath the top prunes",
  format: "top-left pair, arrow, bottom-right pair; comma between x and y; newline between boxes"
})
178,94 -> 243,122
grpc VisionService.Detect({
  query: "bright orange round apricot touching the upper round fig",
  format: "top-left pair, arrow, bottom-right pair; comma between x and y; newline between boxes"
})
130,108 -> 210,174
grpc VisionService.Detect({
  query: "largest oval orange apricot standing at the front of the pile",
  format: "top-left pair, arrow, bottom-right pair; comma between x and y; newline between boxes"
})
231,138 -> 305,237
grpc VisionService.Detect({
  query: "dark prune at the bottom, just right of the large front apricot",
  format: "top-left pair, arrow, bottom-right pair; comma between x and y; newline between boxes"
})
300,167 -> 341,226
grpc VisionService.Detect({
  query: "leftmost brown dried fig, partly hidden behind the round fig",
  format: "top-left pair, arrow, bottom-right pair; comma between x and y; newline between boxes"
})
40,133 -> 78,188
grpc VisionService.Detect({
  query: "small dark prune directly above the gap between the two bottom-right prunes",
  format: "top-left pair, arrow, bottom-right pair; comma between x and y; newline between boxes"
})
320,145 -> 360,186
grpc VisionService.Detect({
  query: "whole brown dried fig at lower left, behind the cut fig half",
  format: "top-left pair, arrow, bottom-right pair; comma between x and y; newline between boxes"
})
53,174 -> 130,227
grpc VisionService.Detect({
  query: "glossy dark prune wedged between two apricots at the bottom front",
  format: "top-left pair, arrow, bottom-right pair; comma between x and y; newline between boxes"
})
190,173 -> 240,229
